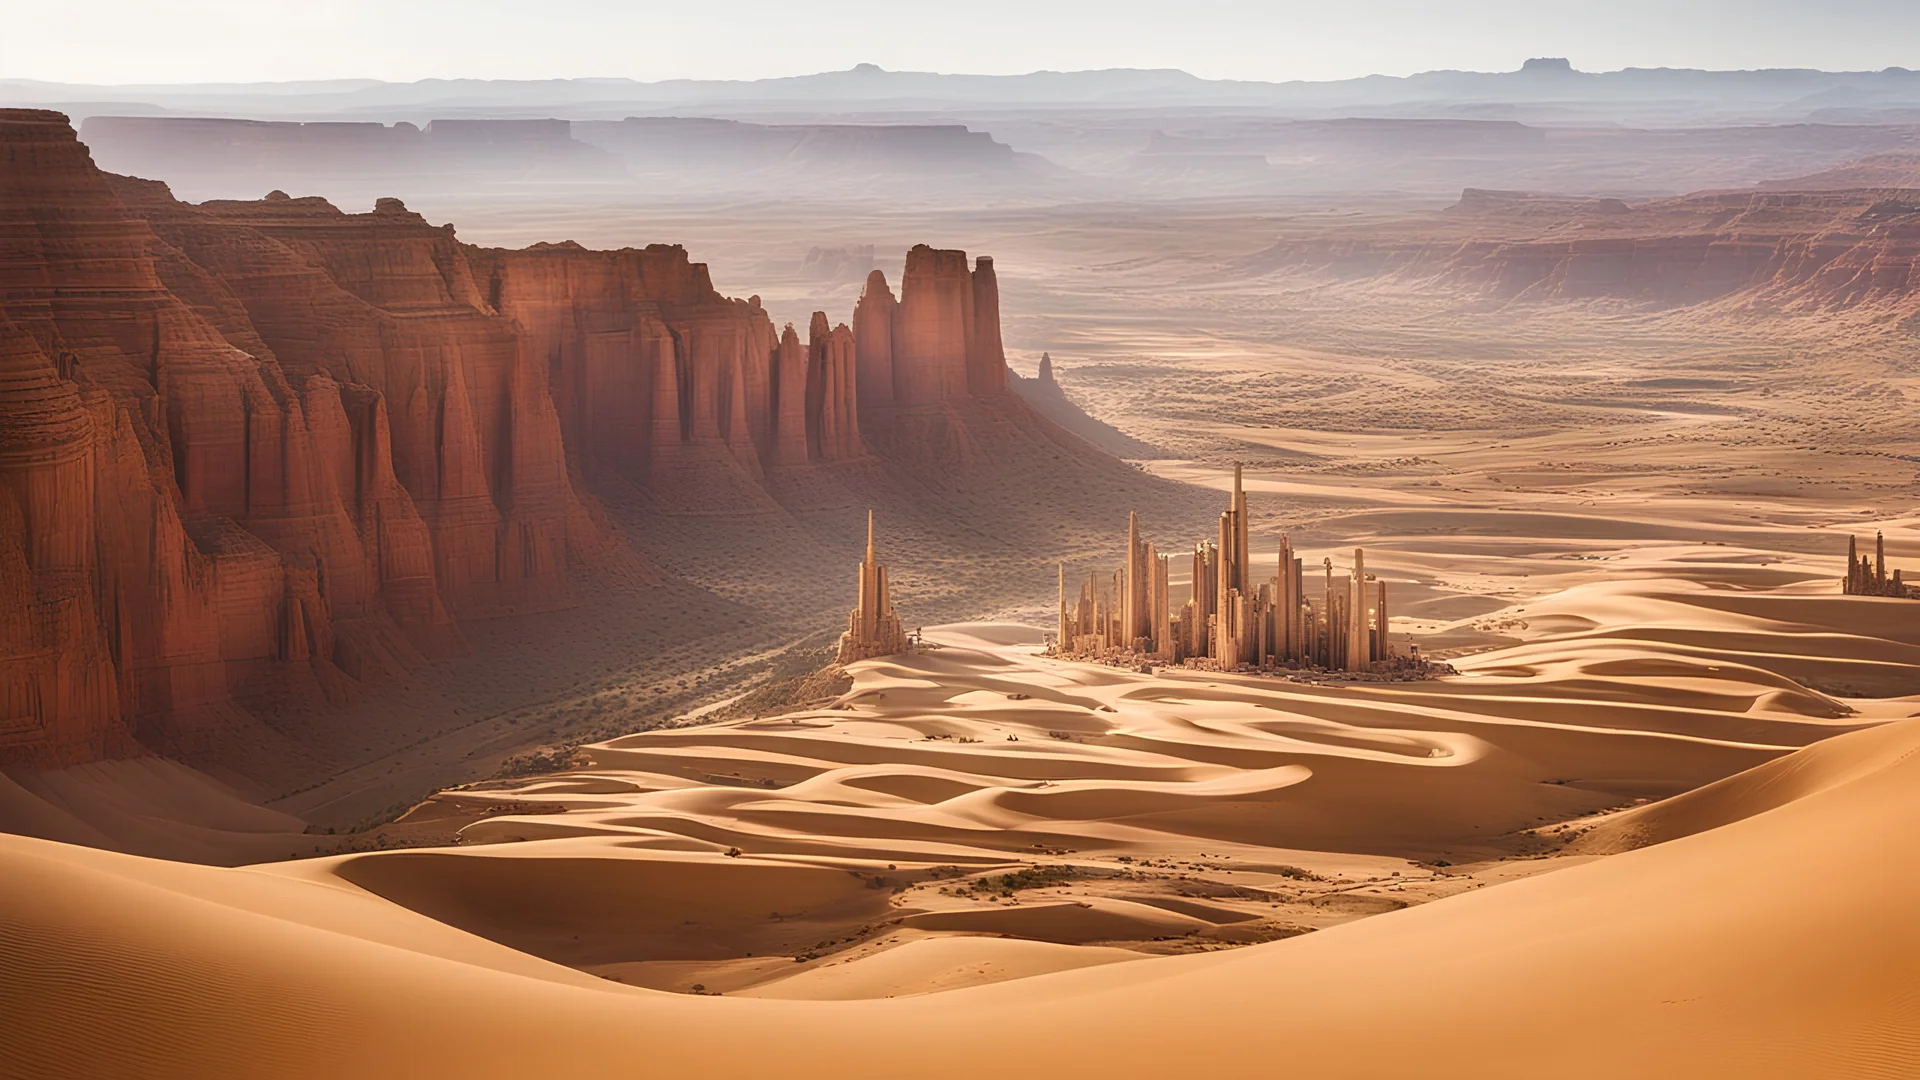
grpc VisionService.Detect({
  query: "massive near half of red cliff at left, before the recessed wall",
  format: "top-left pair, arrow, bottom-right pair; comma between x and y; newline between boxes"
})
0,110 -> 609,765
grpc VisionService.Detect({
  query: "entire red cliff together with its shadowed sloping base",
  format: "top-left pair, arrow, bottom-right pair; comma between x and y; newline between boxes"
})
0,110 -> 1200,824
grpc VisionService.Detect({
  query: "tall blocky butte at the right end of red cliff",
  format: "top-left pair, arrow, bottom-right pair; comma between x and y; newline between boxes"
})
852,244 -> 1006,407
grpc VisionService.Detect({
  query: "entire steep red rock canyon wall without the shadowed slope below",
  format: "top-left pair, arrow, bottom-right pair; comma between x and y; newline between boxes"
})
0,110 -> 1036,767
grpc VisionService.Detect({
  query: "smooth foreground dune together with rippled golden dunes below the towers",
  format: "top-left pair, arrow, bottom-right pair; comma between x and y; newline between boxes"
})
0,557 -> 1920,1076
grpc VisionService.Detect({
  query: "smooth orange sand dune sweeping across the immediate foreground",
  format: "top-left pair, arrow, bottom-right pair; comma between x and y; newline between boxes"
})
0,711 -> 1920,1076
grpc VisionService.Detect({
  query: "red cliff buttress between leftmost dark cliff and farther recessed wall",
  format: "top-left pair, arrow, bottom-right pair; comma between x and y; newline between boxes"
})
121,183 -> 593,617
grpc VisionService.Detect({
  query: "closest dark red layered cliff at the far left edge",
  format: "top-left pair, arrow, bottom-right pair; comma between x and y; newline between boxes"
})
0,110 -> 353,765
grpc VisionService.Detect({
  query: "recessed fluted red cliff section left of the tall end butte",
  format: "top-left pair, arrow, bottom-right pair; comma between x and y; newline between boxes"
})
463,244 -> 866,472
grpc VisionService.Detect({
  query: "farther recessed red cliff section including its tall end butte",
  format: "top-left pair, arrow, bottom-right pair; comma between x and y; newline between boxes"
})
470,242 -> 1006,480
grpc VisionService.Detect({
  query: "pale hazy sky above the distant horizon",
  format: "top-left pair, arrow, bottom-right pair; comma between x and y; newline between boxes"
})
15,0 -> 1920,83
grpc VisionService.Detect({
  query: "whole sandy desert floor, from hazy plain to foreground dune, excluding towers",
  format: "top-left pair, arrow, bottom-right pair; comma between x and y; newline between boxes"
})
0,189 -> 1920,1076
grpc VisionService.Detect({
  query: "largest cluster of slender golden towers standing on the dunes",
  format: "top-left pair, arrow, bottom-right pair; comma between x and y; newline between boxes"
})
1054,465 -> 1394,671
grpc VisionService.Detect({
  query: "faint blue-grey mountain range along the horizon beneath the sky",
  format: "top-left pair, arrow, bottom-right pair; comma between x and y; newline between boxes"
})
11,58 -> 1920,123
